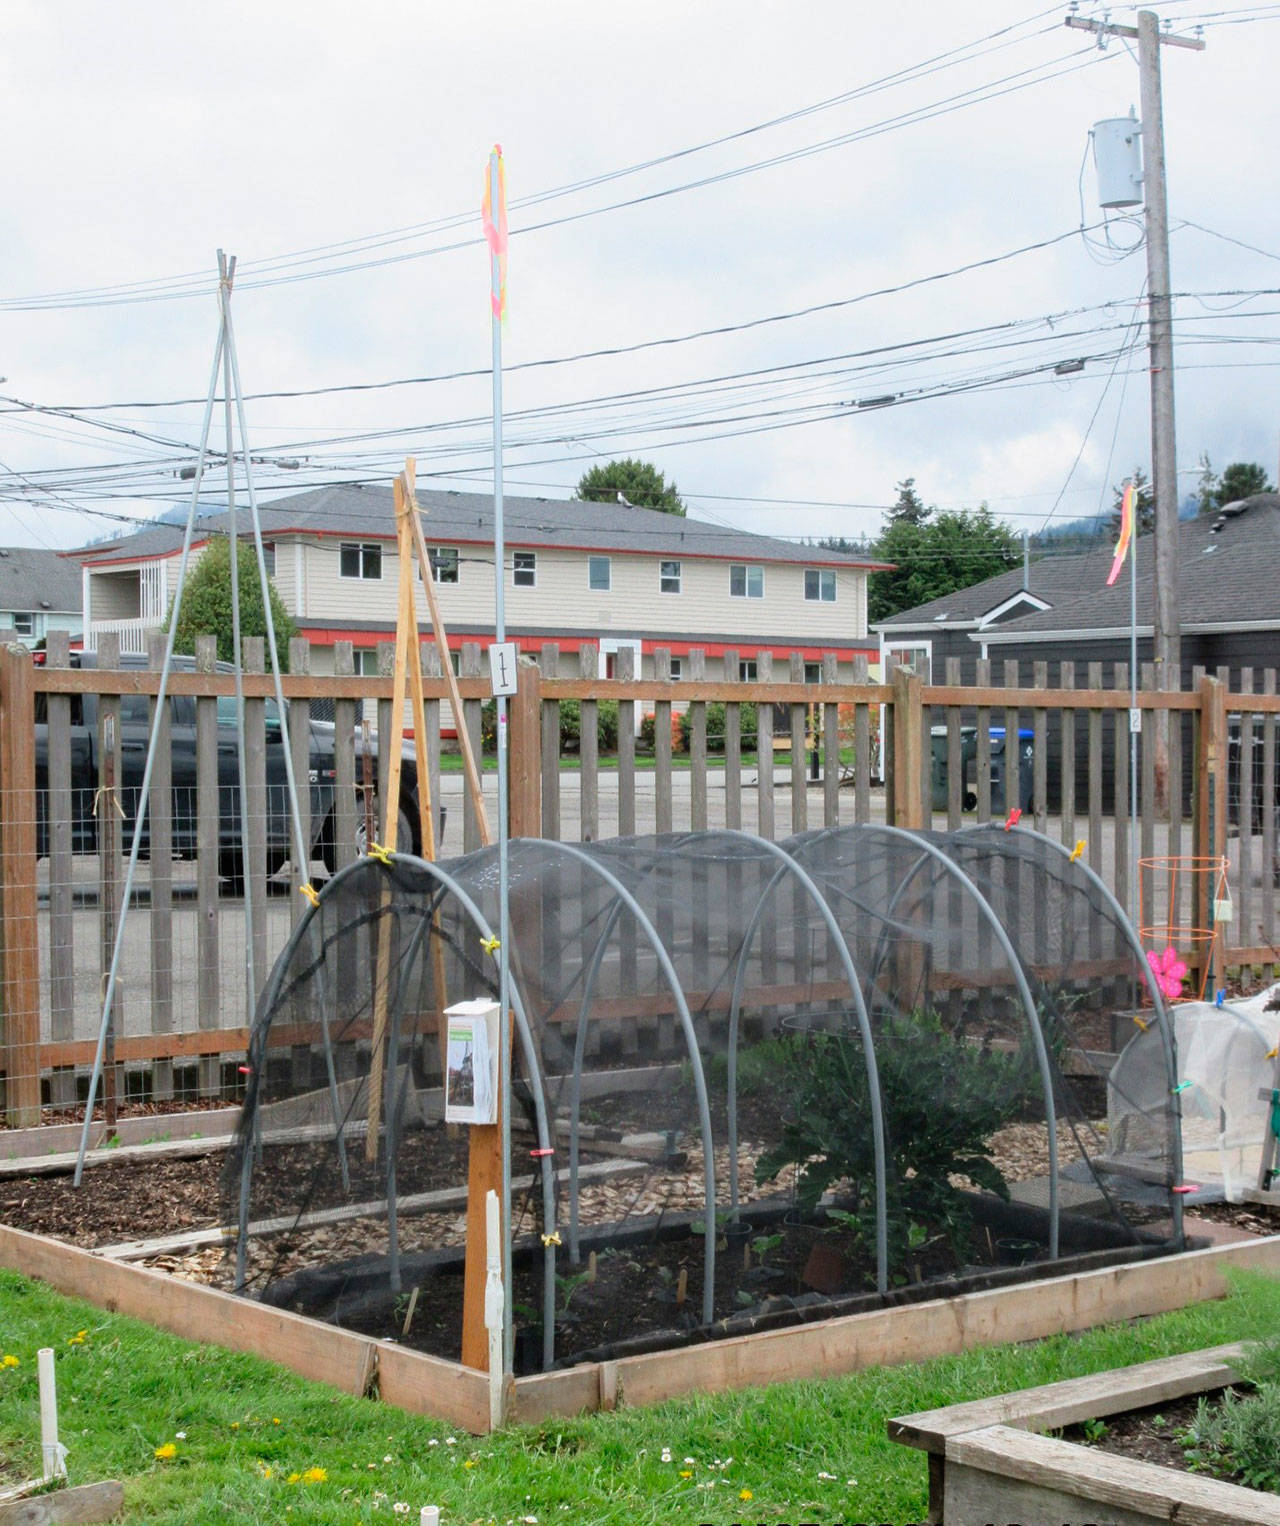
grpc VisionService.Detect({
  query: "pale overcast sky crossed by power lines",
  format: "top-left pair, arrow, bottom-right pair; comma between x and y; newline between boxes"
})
0,0 -> 1280,546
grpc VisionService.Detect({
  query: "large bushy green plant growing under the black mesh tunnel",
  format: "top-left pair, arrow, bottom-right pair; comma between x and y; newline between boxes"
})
755,1012 -> 1036,1262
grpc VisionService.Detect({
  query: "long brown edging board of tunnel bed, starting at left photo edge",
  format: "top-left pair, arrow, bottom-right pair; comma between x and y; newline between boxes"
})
0,1224 -> 375,1395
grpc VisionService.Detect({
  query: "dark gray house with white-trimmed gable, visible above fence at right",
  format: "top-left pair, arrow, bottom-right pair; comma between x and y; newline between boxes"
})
871,493 -> 1280,690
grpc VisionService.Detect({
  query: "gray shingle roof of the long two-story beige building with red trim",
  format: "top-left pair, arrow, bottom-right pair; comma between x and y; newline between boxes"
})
70,487 -> 879,566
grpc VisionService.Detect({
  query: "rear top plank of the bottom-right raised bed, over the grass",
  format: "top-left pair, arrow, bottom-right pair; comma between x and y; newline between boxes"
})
885,1341 -> 1245,1451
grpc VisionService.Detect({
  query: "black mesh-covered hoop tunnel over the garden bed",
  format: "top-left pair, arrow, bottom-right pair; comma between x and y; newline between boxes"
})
224,824 -> 1184,1370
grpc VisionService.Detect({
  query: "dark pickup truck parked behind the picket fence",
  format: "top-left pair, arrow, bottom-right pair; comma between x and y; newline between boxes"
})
35,652 -> 421,885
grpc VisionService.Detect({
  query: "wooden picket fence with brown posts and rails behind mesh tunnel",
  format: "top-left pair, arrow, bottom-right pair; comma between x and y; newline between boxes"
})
0,638 -> 1280,1125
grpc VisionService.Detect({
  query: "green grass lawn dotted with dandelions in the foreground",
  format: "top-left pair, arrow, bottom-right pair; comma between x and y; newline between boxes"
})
0,1271 -> 1280,1526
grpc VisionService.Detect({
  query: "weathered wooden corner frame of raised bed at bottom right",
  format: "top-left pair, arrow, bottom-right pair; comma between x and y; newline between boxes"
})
888,1346 -> 1280,1526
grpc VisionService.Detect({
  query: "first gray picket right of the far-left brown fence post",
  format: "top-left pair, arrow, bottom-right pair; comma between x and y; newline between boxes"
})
44,630 -> 75,1106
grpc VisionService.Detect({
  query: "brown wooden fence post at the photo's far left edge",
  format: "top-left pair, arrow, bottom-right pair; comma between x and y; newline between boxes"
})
0,645 -> 40,1128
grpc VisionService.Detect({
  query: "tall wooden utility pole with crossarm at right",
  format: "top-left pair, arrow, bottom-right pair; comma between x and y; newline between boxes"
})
1066,11 -> 1204,701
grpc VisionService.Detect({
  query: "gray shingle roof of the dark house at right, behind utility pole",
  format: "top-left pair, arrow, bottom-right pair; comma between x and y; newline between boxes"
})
876,493 -> 1280,642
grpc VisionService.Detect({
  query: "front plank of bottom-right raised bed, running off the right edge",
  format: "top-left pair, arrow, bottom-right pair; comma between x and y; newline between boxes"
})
946,1425 -> 1280,1526
